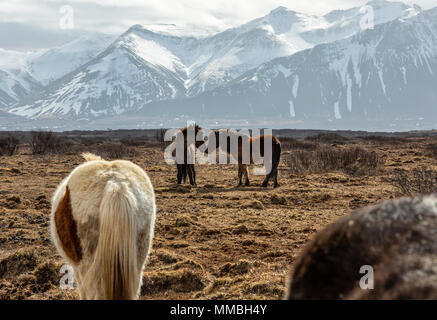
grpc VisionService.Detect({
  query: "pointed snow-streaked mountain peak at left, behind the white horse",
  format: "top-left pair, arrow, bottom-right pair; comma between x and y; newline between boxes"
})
10,30 -> 185,120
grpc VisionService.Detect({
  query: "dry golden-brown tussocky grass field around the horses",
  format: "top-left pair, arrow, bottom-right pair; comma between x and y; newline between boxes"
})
0,131 -> 437,299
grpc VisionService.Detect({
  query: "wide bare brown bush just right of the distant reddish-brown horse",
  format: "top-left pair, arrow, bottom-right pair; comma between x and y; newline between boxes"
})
284,147 -> 384,175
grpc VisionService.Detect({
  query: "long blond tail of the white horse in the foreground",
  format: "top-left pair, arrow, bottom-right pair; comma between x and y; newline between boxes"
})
96,181 -> 140,300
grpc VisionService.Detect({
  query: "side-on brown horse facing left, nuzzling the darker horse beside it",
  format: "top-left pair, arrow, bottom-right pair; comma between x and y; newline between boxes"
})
206,130 -> 281,188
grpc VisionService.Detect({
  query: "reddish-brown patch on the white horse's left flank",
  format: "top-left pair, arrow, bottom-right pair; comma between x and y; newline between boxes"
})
55,186 -> 82,263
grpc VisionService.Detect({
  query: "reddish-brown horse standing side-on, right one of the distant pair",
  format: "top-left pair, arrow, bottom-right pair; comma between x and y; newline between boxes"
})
205,130 -> 281,188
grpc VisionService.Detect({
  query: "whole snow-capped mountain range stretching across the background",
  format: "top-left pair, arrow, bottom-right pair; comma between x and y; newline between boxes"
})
0,0 -> 437,131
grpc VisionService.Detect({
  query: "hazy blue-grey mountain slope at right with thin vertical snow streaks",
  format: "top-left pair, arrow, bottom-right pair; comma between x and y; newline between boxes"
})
145,9 -> 437,122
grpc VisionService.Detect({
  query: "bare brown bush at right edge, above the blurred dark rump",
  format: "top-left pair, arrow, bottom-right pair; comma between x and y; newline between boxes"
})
392,168 -> 437,195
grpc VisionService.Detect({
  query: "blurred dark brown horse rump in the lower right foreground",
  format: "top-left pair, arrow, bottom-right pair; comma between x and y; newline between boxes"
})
288,195 -> 437,299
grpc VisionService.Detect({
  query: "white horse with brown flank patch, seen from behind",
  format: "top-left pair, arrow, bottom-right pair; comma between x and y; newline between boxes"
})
50,154 -> 156,300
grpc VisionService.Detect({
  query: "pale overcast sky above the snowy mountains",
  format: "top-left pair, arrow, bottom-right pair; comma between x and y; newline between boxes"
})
0,0 -> 437,50
